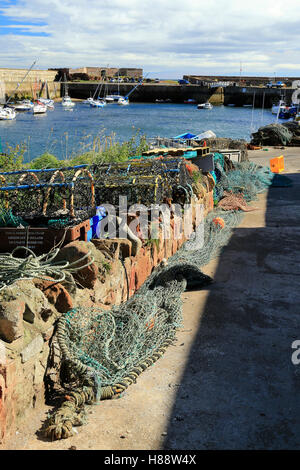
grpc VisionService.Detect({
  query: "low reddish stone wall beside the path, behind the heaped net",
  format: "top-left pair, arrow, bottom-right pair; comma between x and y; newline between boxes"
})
0,188 -> 213,443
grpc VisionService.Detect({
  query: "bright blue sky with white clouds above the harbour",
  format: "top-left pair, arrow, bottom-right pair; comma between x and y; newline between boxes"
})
0,0 -> 300,78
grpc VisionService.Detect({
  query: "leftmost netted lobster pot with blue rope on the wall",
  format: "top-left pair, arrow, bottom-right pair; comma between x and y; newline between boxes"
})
0,165 -> 95,223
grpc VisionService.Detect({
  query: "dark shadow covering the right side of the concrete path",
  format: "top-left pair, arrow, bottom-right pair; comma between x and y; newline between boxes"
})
163,173 -> 300,450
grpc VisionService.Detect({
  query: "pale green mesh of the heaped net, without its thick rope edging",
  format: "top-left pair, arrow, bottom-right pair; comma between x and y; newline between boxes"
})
60,212 -> 241,387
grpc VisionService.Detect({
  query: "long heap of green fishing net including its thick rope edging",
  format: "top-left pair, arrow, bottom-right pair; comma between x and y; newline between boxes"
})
44,211 -> 241,439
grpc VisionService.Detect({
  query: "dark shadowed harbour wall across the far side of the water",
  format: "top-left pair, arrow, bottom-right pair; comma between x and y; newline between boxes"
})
68,82 -> 294,108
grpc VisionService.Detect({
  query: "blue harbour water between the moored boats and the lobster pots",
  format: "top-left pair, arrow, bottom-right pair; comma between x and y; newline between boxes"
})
0,102 -> 276,162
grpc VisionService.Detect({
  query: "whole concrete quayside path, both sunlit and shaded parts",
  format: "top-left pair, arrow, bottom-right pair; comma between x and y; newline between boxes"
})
2,149 -> 300,450
